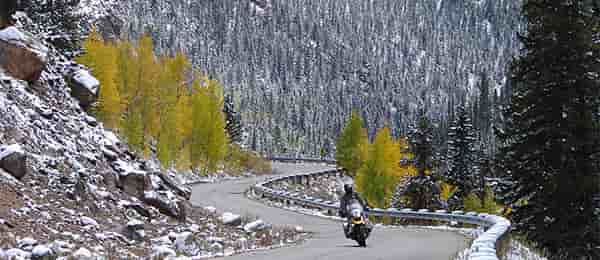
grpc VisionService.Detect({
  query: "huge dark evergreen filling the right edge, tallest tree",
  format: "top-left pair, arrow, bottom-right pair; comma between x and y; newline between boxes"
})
499,0 -> 600,259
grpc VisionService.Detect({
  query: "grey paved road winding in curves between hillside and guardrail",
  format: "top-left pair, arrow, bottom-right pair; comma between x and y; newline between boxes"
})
191,163 -> 468,260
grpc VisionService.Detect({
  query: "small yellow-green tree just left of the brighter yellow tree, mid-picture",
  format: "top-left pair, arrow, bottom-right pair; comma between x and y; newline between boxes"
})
335,112 -> 369,175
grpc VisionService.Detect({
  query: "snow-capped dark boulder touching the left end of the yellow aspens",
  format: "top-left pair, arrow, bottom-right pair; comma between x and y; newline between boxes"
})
68,69 -> 100,111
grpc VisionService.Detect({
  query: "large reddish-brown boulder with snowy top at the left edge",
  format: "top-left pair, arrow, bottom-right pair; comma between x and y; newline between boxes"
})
0,26 -> 48,83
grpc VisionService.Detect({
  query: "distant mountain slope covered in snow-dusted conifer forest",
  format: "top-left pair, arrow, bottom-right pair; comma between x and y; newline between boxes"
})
112,0 -> 521,155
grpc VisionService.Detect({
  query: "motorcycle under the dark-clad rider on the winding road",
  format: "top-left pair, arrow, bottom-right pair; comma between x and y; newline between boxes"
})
344,200 -> 373,247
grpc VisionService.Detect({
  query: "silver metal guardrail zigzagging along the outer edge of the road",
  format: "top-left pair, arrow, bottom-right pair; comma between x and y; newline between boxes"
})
251,162 -> 511,260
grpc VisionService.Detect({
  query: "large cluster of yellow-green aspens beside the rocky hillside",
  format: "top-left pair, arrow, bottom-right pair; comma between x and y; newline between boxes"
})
77,31 -> 270,174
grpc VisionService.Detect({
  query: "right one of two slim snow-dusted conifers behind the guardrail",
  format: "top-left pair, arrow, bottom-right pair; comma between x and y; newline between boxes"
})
445,105 -> 477,208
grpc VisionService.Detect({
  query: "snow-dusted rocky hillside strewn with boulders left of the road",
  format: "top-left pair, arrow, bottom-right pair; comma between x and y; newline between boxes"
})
0,24 -> 299,259
